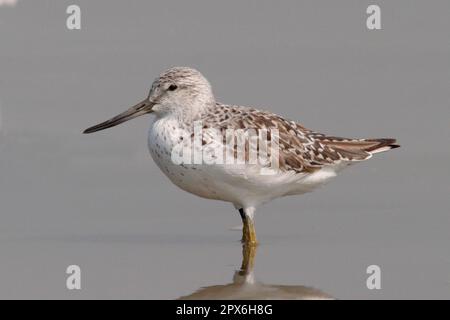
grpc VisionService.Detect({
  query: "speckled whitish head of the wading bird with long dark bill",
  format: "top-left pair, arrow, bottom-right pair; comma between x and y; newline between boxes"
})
83,67 -> 214,133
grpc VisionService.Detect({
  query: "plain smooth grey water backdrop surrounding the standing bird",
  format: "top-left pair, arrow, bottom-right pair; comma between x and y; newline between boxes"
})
0,0 -> 450,299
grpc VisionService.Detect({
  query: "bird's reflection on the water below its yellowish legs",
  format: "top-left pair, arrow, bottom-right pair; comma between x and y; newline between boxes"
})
180,245 -> 333,300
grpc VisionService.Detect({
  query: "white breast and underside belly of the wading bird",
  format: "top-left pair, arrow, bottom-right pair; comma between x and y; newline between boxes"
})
148,118 -> 342,207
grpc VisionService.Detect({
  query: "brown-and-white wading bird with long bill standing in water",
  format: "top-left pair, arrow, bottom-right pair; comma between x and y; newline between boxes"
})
84,67 -> 399,245
